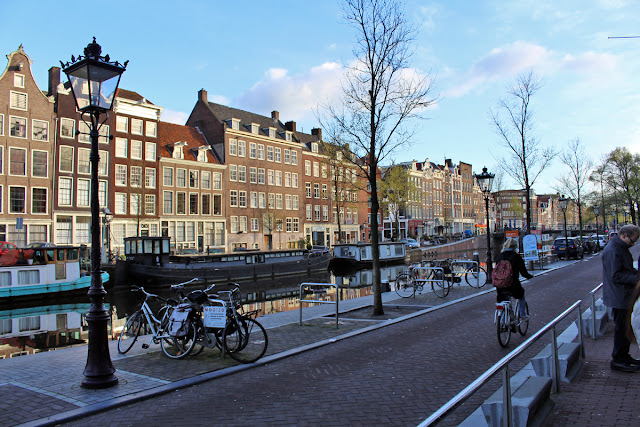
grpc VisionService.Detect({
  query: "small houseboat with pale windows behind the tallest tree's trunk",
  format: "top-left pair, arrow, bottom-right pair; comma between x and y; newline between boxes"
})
332,242 -> 407,268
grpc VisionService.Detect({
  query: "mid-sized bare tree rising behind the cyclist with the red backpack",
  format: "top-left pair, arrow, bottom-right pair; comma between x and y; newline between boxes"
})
489,71 -> 556,232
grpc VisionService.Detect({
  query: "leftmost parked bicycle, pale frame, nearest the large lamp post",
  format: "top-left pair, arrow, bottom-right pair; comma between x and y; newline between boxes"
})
118,279 -> 198,354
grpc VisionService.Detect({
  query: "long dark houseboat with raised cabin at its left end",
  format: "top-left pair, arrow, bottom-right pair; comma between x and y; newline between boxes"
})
116,237 -> 332,286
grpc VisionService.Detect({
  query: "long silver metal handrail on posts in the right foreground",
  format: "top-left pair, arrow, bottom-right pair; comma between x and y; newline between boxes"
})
419,300 -> 584,427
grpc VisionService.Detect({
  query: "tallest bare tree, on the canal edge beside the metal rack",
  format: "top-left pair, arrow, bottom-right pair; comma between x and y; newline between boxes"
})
320,0 -> 435,315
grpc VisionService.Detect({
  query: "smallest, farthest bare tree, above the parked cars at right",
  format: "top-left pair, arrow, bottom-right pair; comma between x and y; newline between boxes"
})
557,138 -> 593,236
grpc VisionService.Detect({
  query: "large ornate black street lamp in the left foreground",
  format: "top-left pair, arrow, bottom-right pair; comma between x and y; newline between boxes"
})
60,37 -> 129,389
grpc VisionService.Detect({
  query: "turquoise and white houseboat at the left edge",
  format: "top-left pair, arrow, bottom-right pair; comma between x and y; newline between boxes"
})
0,246 -> 109,301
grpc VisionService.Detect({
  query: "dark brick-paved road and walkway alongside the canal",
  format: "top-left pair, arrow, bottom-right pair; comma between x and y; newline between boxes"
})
0,256 -> 640,425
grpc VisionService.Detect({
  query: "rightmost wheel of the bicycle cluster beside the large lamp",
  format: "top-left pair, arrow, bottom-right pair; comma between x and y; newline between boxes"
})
222,317 -> 269,363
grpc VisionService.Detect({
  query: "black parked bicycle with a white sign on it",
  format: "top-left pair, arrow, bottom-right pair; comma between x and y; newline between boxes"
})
172,283 -> 269,363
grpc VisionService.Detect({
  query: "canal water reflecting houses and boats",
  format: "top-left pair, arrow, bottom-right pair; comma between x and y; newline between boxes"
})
0,264 -> 405,363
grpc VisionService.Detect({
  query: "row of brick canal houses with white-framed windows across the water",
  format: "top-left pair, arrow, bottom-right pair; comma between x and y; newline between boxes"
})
0,46 -> 576,253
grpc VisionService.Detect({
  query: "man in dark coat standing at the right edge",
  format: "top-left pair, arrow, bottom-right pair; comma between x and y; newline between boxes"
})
602,225 -> 640,372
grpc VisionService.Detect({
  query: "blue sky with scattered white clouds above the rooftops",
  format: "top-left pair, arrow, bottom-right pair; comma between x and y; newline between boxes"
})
0,0 -> 640,193
